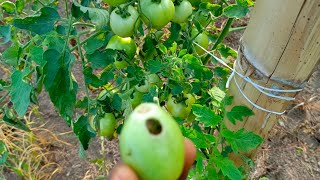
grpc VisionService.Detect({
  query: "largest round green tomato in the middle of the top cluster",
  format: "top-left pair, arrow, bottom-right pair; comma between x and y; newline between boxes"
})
140,0 -> 174,29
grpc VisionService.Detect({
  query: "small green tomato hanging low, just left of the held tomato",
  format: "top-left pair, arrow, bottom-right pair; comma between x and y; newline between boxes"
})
99,113 -> 117,138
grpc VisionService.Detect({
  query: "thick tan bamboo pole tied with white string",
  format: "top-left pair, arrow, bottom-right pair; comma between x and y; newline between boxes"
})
226,0 -> 320,161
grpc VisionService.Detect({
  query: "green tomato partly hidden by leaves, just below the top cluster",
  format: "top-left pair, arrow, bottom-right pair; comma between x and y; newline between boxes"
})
106,35 -> 137,69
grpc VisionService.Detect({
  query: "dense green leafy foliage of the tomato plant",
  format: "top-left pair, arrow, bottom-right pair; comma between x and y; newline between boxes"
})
0,0 -> 262,179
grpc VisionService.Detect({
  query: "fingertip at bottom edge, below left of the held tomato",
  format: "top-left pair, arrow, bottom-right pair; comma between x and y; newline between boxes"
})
109,164 -> 138,180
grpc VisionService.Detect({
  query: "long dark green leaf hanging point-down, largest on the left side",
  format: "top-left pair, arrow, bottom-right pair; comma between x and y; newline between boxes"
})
43,49 -> 78,125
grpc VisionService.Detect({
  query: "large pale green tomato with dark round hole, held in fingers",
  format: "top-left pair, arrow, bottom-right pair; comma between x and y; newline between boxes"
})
119,103 -> 184,180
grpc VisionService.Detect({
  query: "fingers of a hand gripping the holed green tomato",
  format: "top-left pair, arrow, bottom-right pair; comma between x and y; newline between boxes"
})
110,138 -> 196,180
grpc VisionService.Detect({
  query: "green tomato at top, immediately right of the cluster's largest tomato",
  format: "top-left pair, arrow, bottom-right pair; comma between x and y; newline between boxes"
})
172,0 -> 192,23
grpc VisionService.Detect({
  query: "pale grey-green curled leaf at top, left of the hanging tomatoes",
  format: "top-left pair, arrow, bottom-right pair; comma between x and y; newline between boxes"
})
72,1 -> 109,29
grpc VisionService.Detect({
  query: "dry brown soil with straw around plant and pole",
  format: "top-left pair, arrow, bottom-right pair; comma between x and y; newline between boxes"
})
0,4 -> 320,180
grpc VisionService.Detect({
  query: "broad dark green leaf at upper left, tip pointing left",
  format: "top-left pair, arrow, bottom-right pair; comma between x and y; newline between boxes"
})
13,7 -> 60,35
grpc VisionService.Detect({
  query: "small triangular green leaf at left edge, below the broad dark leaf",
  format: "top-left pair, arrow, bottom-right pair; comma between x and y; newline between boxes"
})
2,42 -> 21,66
